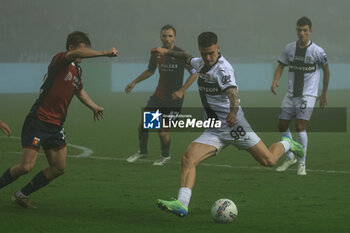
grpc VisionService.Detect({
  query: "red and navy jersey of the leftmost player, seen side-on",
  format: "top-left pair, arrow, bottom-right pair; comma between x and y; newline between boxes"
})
30,52 -> 83,125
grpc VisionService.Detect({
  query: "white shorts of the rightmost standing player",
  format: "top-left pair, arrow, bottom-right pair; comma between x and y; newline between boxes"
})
279,94 -> 316,121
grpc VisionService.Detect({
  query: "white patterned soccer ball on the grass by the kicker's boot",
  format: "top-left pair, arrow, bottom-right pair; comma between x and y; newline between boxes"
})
211,198 -> 238,223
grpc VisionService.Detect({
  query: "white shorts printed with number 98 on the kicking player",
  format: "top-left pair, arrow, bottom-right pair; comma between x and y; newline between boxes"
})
193,109 -> 260,153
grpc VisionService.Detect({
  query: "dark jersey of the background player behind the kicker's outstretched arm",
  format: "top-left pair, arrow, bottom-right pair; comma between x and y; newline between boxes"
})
148,46 -> 195,101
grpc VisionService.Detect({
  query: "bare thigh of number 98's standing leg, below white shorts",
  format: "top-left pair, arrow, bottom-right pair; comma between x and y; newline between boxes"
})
182,142 -> 217,166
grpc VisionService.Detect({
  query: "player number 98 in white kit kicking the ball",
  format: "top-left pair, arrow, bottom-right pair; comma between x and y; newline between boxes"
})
152,32 -> 304,217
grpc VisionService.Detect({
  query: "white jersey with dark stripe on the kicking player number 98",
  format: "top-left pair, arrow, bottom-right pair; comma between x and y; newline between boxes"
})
191,54 -> 238,123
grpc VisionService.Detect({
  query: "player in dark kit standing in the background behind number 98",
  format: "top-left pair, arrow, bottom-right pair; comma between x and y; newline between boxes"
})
125,25 -> 197,166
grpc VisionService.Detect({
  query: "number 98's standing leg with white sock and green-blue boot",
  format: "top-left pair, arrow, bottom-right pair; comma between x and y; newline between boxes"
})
157,142 -> 216,217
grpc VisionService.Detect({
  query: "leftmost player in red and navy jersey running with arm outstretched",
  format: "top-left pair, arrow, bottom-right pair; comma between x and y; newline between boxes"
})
0,31 -> 118,208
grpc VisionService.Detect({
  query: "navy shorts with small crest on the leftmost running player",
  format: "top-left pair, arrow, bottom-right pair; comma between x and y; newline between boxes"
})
21,115 -> 67,151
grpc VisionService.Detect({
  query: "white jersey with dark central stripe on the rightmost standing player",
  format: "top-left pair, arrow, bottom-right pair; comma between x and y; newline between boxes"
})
278,41 -> 327,97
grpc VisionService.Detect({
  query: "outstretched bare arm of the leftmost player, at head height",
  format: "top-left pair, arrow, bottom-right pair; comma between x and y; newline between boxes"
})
66,47 -> 119,62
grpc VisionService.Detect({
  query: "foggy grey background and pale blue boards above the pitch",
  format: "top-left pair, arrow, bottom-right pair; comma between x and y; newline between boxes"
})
0,0 -> 350,92
